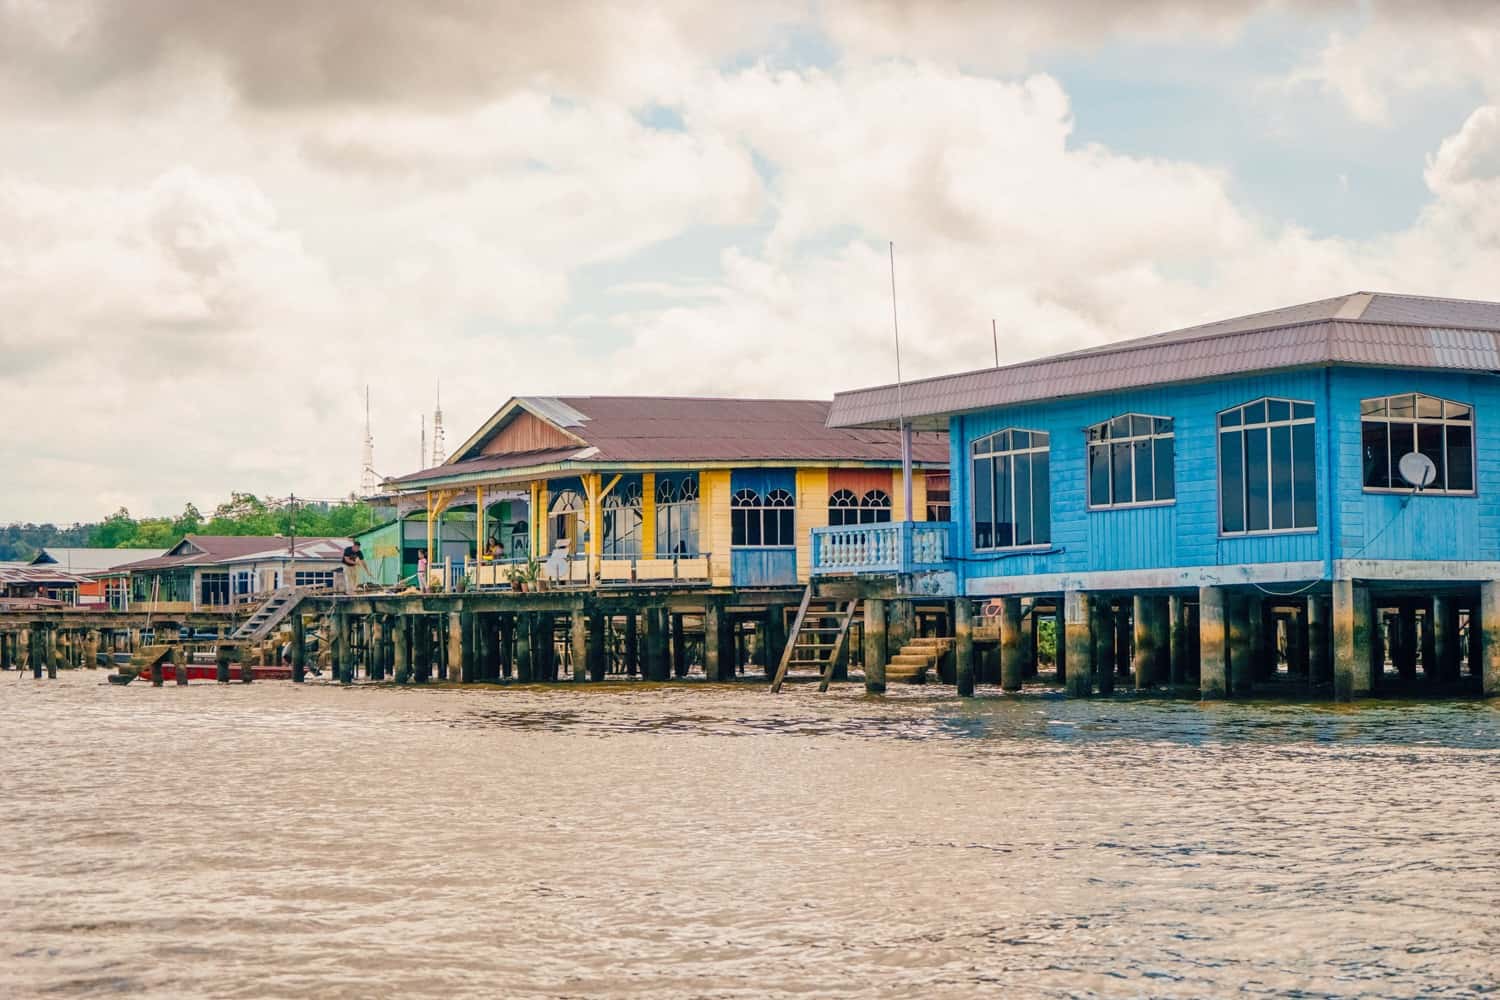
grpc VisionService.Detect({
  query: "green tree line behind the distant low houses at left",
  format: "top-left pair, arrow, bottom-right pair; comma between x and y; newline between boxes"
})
0,493 -> 384,562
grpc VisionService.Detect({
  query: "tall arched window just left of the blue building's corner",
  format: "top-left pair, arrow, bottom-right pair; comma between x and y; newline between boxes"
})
1220,399 -> 1317,535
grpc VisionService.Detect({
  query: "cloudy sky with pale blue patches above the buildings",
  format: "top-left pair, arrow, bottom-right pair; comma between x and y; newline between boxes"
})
0,0 -> 1500,523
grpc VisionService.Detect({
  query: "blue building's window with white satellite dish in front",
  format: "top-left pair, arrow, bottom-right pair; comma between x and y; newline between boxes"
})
1359,393 -> 1475,493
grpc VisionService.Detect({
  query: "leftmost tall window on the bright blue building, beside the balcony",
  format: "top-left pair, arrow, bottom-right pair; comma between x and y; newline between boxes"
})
972,430 -> 1052,549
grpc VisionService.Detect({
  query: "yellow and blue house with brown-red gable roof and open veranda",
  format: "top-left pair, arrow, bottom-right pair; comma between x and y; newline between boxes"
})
386,396 -> 948,588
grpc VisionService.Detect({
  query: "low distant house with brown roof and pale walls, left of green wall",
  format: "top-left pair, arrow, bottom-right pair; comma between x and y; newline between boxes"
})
108,535 -> 350,612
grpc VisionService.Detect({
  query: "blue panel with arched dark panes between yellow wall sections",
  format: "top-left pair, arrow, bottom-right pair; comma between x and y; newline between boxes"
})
729,469 -> 797,586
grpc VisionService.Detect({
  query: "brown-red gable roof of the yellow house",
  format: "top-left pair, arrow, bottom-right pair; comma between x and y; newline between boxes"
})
392,396 -> 948,486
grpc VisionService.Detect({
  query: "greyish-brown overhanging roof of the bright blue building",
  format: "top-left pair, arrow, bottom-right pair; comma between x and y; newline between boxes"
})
830,292 -> 1500,427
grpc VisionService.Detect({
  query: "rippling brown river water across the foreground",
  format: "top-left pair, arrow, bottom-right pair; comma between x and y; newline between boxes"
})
0,672 -> 1500,999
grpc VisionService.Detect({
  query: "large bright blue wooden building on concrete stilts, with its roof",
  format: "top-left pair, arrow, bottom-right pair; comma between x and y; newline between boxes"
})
813,292 -> 1500,697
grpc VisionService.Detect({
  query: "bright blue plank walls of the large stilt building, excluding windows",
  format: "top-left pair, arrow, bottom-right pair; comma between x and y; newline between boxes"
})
950,369 -> 1500,590
